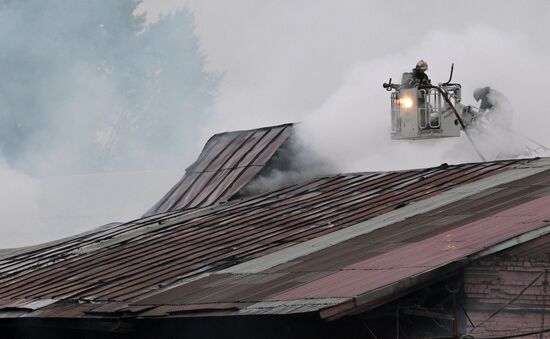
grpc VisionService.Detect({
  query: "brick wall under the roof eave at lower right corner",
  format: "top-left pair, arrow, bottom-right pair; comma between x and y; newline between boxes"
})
463,236 -> 550,338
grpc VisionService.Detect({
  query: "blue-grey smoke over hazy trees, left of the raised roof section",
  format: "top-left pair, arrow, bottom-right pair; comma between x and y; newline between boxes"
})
0,0 -> 220,247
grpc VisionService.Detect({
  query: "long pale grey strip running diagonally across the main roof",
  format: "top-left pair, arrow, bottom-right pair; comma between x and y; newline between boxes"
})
217,165 -> 549,274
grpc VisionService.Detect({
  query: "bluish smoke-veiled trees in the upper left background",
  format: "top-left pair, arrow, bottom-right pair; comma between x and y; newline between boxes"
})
0,0 -> 217,175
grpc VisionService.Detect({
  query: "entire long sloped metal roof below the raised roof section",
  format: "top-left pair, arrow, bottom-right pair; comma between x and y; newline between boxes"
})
0,159 -> 550,318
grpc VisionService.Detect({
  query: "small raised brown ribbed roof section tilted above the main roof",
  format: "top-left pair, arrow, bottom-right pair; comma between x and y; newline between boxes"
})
145,124 -> 292,216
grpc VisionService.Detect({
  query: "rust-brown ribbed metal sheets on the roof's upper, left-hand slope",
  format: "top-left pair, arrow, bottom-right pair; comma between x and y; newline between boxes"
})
0,162 -> 536,298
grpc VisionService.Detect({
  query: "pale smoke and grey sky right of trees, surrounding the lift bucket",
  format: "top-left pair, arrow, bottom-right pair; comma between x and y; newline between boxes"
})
160,0 -> 550,172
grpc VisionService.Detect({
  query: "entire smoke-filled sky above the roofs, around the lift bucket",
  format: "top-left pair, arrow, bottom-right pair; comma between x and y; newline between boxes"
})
0,0 -> 550,247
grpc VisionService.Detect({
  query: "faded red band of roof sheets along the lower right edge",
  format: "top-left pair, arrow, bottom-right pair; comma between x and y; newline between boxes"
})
271,195 -> 550,300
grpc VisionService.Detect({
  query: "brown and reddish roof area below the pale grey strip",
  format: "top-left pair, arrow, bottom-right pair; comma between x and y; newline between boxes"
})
132,167 -> 550,322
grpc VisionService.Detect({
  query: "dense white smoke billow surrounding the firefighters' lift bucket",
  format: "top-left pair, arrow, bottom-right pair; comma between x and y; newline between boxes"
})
301,26 -> 550,171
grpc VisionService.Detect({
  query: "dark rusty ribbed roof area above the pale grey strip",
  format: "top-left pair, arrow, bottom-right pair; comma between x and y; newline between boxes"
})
0,161 -> 517,301
